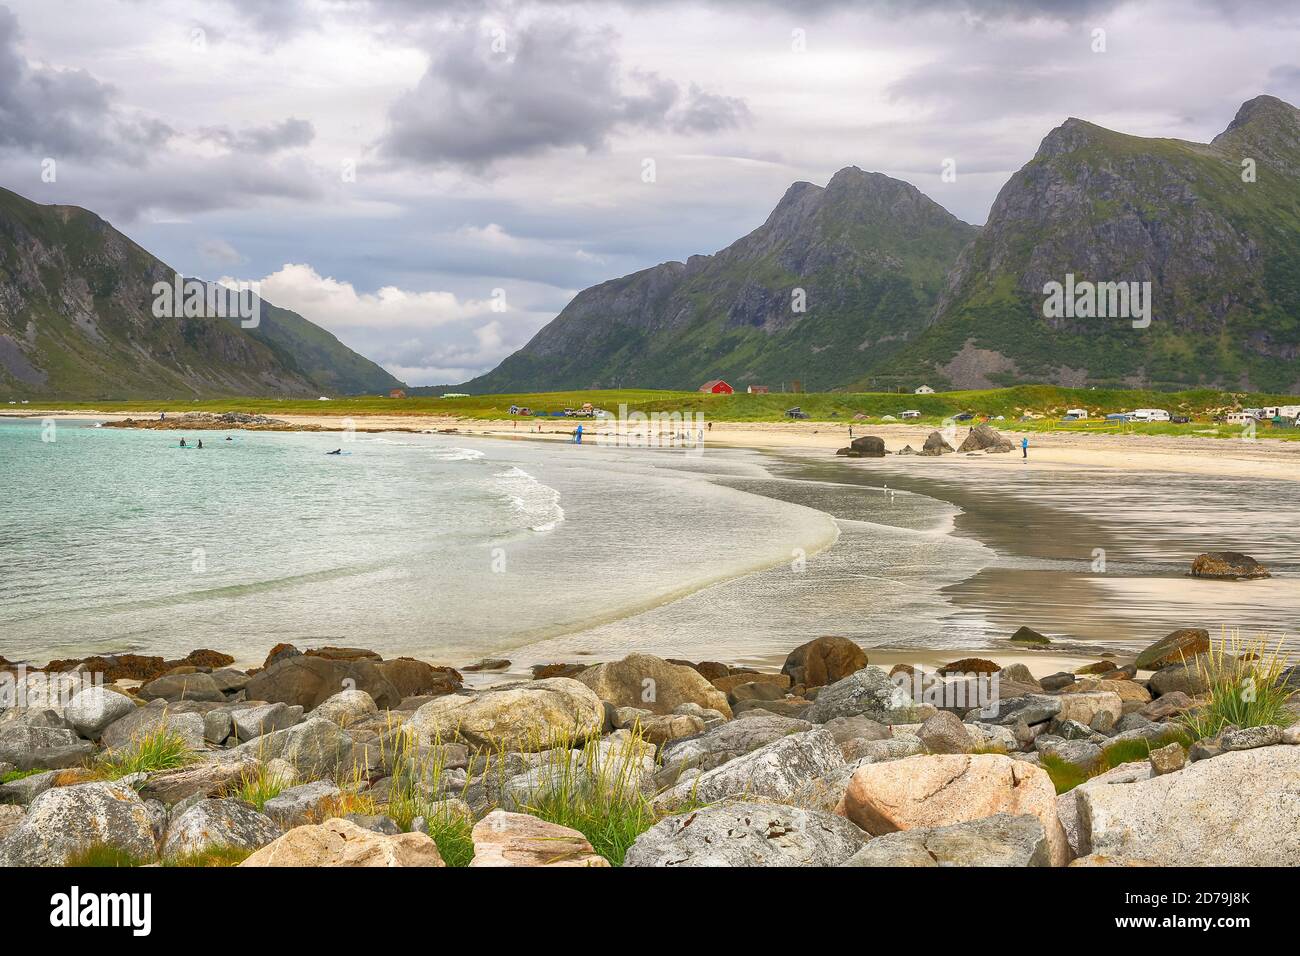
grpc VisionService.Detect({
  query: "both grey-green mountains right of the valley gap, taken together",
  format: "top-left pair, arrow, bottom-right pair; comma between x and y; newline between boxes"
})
460,96 -> 1300,393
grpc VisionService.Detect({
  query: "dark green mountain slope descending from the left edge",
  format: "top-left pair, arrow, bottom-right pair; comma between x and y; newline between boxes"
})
0,189 -> 402,401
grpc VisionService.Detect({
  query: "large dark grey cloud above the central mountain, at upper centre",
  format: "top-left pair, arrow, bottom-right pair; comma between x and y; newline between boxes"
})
380,20 -> 749,169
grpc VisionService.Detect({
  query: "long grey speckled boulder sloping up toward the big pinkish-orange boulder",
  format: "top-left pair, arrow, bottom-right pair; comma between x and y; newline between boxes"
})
654,727 -> 844,810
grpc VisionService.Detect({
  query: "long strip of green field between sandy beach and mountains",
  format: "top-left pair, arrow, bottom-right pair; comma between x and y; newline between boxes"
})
10,385 -> 1300,438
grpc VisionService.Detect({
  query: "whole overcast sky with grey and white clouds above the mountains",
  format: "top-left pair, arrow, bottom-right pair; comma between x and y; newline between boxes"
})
0,0 -> 1300,385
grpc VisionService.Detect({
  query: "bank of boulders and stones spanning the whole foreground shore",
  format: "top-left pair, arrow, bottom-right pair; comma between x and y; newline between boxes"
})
0,630 -> 1300,868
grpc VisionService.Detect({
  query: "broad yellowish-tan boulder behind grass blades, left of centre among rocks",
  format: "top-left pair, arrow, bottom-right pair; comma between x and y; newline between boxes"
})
406,681 -> 603,752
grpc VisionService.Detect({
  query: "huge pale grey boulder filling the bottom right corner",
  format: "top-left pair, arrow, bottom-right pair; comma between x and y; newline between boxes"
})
1079,747 -> 1300,866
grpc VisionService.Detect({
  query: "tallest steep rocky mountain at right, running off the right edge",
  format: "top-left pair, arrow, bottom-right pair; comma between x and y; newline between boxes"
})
891,96 -> 1300,393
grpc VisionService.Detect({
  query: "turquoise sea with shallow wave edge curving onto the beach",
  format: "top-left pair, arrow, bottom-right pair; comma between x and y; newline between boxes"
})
0,420 -> 837,662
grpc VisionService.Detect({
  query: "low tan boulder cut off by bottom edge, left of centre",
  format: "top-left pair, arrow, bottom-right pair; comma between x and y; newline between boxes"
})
239,819 -> 445,866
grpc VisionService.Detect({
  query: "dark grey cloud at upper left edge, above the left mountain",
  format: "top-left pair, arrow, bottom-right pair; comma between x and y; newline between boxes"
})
0,7 -> 173,160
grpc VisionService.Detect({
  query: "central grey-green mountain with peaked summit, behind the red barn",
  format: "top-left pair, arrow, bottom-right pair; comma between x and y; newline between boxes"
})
458,166 -> 978,393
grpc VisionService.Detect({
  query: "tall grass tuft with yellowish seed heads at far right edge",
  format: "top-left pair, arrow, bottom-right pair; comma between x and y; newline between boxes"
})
1178,635 -> 1295,740
